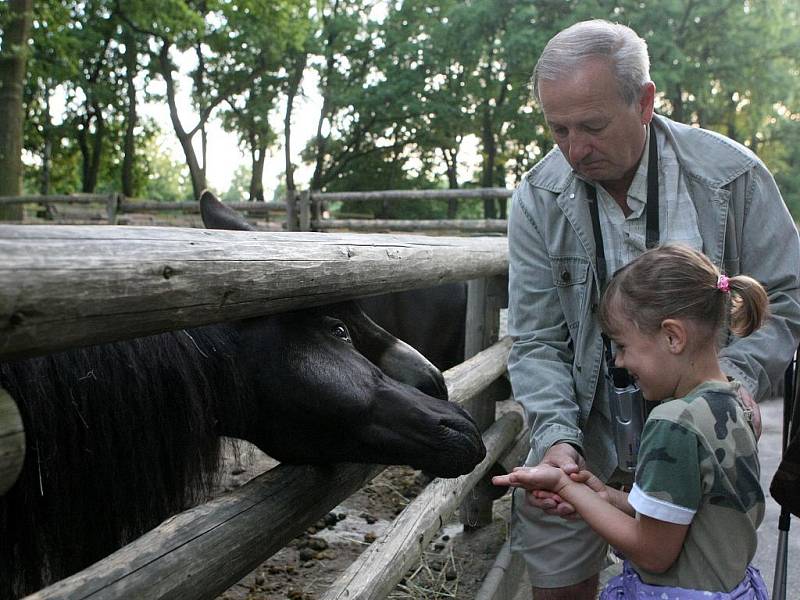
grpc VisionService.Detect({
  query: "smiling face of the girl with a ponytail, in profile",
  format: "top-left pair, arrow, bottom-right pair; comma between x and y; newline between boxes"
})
608,317 -> 681,402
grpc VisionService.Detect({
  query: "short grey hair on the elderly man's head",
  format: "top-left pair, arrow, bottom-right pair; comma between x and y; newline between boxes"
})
531,19 -> 650,106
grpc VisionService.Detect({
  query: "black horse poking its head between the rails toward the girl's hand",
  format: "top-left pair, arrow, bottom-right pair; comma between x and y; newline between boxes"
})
0,241 -> 485,598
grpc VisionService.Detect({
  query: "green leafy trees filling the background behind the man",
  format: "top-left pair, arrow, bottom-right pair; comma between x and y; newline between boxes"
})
6,0 -> 800,218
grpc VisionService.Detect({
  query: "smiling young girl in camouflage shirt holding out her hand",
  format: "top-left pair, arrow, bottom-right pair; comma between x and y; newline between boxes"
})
492,245 -> 768,600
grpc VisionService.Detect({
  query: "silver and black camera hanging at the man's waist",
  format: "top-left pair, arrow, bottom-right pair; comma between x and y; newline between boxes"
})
606,365 -> 647,473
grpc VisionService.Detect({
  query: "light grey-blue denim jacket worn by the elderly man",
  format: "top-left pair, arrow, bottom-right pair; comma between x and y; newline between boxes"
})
508,111 -> 800,479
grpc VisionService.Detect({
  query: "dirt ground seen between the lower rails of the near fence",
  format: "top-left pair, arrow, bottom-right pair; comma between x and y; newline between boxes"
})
209,406 -> 511,600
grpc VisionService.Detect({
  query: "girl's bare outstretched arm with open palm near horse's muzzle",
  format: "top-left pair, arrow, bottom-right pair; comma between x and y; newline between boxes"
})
492,465 -> 689,573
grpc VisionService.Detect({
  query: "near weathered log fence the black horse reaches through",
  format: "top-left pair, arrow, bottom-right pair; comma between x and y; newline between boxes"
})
0,225 -> 527,600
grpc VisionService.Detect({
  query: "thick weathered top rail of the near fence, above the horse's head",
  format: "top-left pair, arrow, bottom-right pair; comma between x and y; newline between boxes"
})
0,225 -> 508,359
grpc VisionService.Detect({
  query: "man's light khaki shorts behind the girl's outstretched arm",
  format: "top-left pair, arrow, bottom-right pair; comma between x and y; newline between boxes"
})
511,471 -> 630,588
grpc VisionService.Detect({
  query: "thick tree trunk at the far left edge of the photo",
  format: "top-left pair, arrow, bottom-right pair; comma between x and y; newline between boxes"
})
0,0 -> 33,221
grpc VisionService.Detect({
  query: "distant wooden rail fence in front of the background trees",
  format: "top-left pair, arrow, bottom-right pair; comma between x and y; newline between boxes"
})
0,188 -> 512,234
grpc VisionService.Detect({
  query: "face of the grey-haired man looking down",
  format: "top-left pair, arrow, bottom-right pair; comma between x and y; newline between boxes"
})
539,58 -> 655,190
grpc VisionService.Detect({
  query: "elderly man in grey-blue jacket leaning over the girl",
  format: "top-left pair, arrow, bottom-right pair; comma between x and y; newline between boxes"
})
508,16 -> 800,600
